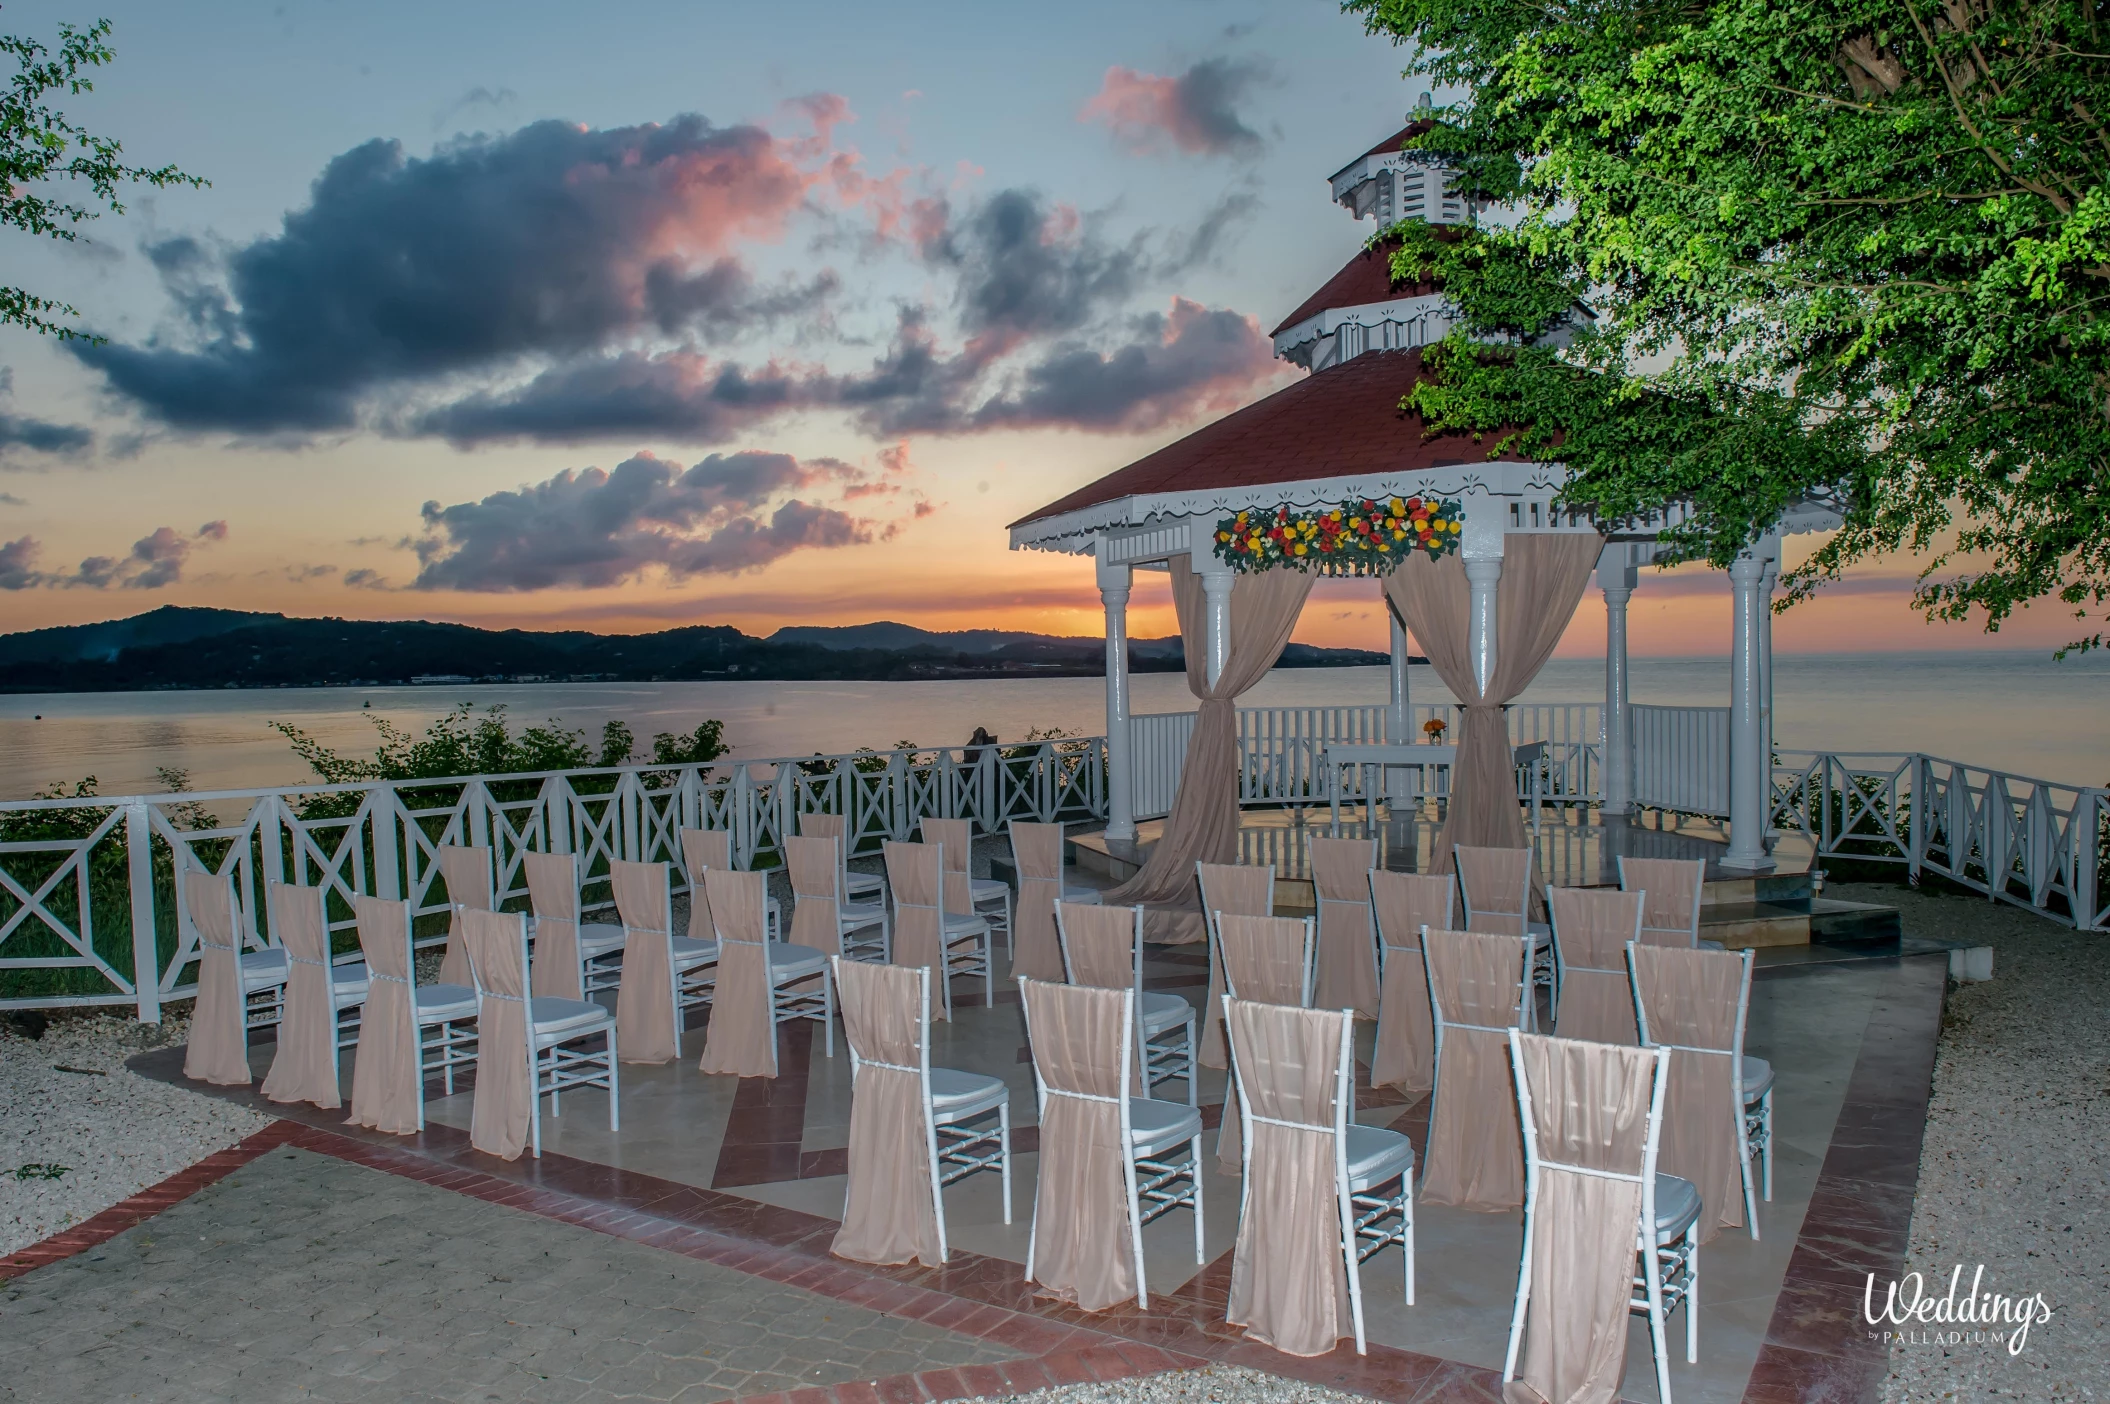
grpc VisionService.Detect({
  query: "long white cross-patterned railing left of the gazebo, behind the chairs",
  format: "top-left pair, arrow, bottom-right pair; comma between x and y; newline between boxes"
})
0,737 -> 1106,1022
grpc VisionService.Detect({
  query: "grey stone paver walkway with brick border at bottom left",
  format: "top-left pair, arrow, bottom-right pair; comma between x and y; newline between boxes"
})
0,1146 -> 1017,1404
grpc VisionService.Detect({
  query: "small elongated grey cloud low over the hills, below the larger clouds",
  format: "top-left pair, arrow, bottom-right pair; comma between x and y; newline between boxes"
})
414,452 -> 882,591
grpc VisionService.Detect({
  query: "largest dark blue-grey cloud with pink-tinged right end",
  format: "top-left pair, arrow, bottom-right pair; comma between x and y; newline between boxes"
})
70,116 -> 827,433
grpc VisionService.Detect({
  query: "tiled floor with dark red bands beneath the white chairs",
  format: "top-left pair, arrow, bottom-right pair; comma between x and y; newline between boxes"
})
70,937 -> 1943,1402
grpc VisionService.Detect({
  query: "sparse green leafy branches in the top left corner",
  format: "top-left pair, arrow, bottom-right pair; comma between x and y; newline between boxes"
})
0,19 -> 209,340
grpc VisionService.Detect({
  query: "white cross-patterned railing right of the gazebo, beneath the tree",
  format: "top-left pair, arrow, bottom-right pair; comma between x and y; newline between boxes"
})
1772,752 -> 2110,931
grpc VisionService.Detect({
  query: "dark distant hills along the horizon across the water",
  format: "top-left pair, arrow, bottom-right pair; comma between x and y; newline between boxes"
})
0,606 -> 1384,692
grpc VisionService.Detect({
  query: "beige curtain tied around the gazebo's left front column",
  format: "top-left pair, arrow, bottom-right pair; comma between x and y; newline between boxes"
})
1106,555 -> 1312,937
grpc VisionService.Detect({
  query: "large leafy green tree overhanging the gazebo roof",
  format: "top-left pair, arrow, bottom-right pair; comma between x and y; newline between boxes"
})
1346,0 -> 2110,646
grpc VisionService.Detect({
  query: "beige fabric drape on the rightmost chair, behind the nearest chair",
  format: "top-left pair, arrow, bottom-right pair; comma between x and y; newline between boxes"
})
1633,946 -> 1743,1244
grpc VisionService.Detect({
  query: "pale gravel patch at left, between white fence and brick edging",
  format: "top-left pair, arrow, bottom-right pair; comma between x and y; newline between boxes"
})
0,1013 -> 270,1252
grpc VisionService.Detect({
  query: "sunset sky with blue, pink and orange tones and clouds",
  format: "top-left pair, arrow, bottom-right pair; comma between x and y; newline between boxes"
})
0,0 -> 2070,654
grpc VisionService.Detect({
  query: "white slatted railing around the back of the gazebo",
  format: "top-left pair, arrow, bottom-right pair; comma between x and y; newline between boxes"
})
1129,703 -> 1604,819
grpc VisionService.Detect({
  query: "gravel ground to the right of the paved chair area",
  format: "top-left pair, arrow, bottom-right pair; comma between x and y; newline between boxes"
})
1829,885 -> 2110,1404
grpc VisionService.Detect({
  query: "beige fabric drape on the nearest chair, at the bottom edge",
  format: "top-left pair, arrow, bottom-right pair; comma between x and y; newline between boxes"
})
1502,1035 -> 1654,1404
